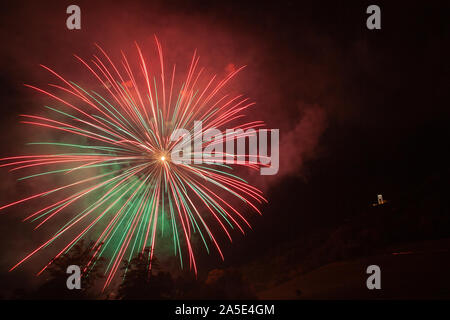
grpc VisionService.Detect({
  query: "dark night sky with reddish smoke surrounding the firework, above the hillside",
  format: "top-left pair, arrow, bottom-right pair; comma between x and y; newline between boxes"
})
0,0 -> 450,296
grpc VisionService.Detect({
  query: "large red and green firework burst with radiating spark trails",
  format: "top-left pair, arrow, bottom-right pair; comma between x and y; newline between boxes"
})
0,37 -> 266,288
